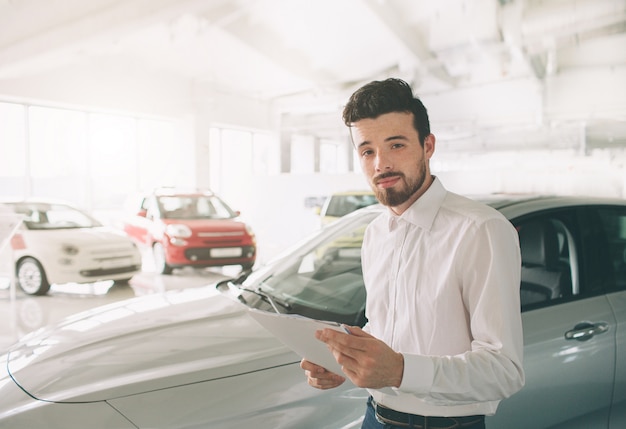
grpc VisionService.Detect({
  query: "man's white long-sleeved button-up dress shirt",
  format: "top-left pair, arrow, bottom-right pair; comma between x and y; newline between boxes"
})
362,178 -> 524,416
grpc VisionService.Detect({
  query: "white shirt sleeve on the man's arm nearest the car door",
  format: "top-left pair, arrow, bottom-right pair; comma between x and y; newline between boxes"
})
397,218 -> 524,405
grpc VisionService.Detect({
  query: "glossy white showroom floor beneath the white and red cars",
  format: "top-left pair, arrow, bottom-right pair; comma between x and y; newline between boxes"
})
0,249 -> 240,354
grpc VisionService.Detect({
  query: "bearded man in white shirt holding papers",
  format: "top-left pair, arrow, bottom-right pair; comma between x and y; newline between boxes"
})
301,79 -> 524,429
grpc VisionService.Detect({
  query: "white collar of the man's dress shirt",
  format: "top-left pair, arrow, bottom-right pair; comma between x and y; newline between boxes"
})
387,176 -> 447,230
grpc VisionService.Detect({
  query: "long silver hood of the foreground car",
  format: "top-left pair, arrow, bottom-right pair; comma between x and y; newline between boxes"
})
7,286 -> 292,402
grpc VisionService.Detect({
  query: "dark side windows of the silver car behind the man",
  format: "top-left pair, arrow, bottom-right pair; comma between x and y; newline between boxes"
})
514,206 -> 626,310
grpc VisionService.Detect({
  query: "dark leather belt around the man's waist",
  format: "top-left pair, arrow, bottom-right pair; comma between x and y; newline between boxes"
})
372,400 -> 485,429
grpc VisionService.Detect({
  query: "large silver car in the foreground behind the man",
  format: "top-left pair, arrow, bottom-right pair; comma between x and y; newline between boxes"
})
0,197 -> 626,429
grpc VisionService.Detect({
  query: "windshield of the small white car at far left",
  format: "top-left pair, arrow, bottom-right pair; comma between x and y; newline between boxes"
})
12,203 -> 102,229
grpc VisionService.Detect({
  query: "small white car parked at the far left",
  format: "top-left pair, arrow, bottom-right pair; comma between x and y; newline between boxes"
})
0,201 -> 141,295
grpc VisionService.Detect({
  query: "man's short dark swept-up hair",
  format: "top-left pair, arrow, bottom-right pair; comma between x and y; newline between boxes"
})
343,78 -> 430,146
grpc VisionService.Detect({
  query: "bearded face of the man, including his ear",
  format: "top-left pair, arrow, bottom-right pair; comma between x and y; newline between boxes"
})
351,112 -> 435,213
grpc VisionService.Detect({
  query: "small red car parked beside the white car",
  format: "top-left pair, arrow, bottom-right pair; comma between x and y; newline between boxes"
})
124,189 -> 256,274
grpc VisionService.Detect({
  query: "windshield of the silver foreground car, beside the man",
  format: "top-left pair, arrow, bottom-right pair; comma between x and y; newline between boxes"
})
236,206 -> 380,326
